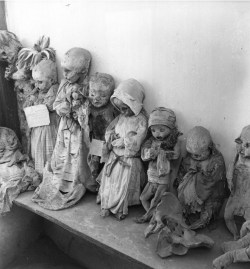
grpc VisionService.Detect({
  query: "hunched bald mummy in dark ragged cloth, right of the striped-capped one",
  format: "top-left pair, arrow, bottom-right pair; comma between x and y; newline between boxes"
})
178,126 -> 226,229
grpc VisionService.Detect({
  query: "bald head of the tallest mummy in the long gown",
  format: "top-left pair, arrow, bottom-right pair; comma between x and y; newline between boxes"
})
61,48 -> 91,83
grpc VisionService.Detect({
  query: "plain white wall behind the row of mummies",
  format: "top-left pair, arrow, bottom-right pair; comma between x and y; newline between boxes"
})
6,0 -> 250,163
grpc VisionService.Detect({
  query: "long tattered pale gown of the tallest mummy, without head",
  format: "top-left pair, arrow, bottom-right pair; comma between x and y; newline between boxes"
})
32,80 -> 91,210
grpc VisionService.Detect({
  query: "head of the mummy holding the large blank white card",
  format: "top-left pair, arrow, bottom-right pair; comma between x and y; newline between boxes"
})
32,59 -> 57,92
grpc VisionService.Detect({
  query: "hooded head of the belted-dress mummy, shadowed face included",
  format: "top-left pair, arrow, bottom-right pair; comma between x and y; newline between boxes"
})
110,78 -> 145,117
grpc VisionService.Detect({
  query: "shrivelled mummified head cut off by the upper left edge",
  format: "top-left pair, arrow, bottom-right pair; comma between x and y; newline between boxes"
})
0,30 -> 22,63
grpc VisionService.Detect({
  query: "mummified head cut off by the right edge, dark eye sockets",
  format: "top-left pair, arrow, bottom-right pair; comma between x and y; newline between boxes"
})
235,125 -> 250,158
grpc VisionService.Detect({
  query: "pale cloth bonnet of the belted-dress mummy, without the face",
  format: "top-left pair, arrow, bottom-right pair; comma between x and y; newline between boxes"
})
110,78 -> 145,116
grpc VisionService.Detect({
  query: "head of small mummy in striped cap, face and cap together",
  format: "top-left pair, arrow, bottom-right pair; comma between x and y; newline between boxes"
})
148,107 -> 176,140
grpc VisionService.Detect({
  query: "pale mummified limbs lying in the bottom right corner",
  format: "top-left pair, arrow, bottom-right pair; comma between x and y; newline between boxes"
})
213,220 -> 250,269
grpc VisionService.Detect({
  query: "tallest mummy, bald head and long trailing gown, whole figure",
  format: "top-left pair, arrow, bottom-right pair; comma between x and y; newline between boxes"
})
32,48 -> 91,210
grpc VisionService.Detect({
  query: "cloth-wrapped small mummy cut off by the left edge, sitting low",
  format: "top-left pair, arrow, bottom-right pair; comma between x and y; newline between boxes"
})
0,127 -> 40,214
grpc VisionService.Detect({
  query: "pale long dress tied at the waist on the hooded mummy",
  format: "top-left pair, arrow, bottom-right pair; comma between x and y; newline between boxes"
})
99,112 -> 147,215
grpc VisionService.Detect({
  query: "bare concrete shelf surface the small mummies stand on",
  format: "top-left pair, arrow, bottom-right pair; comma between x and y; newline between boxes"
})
15,192 -> 249,269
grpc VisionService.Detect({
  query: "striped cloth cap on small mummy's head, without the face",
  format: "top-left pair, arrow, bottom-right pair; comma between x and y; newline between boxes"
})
148,107 -> 176,129
